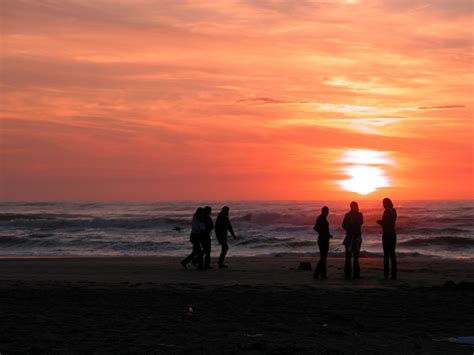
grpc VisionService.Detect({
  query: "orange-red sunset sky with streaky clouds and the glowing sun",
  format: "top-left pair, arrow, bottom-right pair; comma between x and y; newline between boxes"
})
0,0 -> 474,200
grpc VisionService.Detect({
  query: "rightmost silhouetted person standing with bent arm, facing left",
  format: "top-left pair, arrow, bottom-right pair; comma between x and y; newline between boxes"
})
377,198 -> 397,280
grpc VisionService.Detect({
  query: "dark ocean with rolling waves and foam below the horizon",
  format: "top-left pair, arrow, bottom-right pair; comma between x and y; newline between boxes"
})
0,201 -> 474,259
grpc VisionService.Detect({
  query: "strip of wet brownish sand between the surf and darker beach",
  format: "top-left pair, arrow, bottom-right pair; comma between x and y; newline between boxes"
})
0,256 -> 474,288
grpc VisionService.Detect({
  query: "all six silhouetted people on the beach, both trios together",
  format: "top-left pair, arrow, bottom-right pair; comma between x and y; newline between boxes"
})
181,198 -> 397,280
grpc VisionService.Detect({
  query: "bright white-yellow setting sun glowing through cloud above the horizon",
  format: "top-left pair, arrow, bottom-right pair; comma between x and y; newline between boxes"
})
338,150 -> 395,195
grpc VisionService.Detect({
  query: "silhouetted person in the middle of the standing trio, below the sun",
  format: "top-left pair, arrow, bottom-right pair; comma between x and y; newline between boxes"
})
342,201 -> 364,279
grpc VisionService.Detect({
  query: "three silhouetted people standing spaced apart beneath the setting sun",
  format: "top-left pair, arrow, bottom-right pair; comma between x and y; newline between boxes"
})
313,198 -> 397,280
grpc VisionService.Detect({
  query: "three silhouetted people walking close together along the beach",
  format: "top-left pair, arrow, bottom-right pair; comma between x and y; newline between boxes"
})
181,206 -> 237,270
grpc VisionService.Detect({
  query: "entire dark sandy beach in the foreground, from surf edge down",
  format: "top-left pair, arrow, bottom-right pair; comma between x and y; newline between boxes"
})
0,257 -> 474,355
